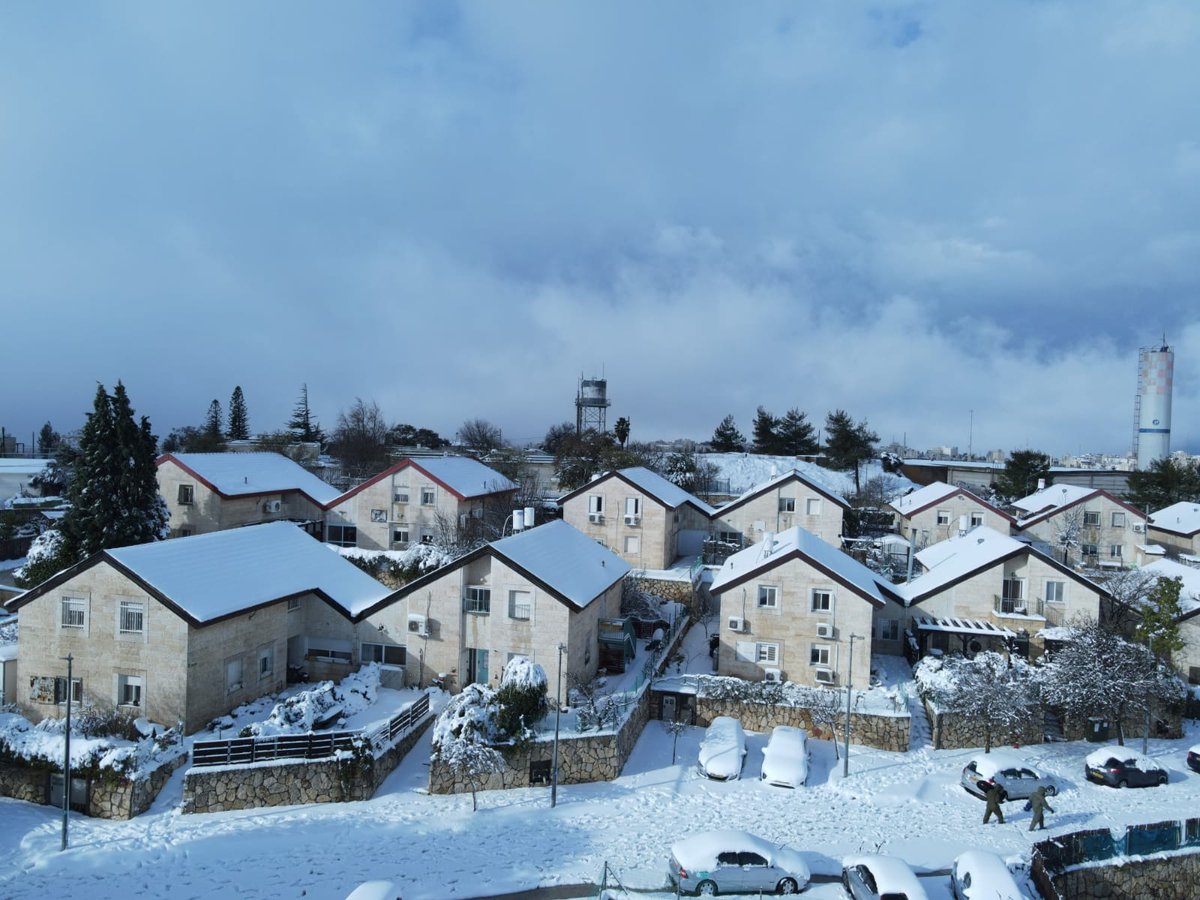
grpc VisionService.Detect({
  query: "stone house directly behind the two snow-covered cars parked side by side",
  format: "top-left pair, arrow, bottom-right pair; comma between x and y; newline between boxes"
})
709,526 -> 902,686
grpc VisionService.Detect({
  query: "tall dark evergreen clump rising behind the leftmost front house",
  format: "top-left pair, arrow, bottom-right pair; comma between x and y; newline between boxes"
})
62,382 -> 167,564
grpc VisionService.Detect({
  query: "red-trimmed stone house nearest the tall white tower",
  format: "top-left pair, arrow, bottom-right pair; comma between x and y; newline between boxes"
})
1013,484 -> 1146,569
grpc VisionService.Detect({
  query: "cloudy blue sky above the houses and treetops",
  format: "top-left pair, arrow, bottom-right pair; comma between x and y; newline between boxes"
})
0,0 -> 1200,454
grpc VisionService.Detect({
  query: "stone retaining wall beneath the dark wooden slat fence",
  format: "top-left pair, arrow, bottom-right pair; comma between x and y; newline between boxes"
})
182,715 -> 433,812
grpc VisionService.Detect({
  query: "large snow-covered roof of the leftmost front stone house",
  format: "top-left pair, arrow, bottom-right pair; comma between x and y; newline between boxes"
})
13,522 -> 391,625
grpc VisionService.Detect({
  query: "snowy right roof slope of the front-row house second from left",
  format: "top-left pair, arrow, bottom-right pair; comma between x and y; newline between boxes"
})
487,520 -> 630,608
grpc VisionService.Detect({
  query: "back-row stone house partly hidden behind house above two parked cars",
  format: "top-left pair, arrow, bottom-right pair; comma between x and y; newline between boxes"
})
710,469 -> 850,547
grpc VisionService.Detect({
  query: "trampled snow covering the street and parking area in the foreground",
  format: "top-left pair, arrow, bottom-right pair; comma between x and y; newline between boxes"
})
0,628 -> 1200,900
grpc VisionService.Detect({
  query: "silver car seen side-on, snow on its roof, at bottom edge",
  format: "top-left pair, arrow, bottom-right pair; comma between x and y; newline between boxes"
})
667,829 -> 811,896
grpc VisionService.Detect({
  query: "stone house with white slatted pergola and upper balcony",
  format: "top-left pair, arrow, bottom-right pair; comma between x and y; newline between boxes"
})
894,527 -> 1109,656
